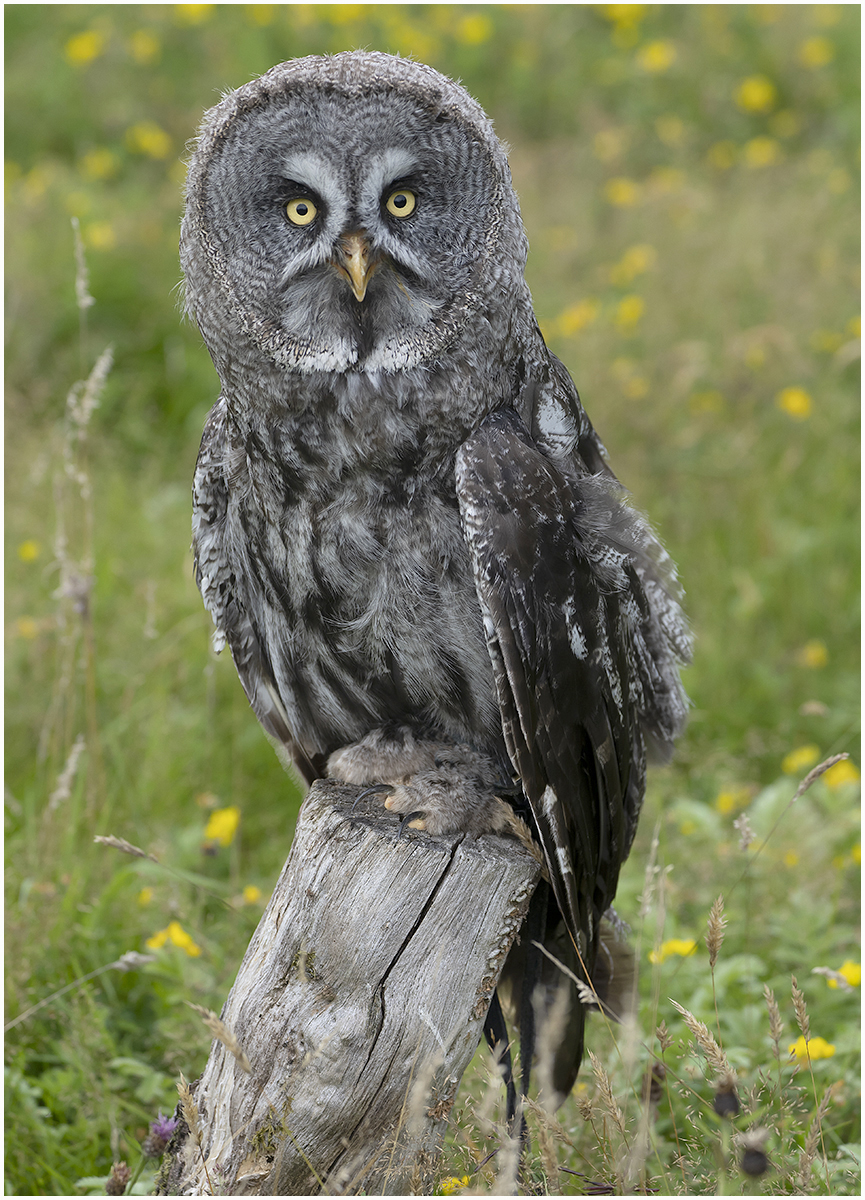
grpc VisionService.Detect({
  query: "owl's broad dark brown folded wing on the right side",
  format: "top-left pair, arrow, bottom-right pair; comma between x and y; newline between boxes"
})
457,409 -> 649,972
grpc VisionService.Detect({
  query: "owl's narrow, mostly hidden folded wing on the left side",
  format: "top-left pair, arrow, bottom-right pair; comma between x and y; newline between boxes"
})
192,398 -> 318,784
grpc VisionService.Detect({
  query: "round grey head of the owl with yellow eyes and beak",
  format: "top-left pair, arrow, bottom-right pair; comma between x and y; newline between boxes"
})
181,50 -> 527,374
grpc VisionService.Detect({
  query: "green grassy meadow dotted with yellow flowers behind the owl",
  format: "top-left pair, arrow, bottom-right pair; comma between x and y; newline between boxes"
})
5,5 -> 860,1194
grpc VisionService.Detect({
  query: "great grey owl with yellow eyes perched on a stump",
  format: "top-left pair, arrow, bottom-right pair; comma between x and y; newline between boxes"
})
181,52 -> 689,1092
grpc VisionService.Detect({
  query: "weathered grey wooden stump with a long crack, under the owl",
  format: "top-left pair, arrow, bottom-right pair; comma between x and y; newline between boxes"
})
162,781 -> 540,1195
